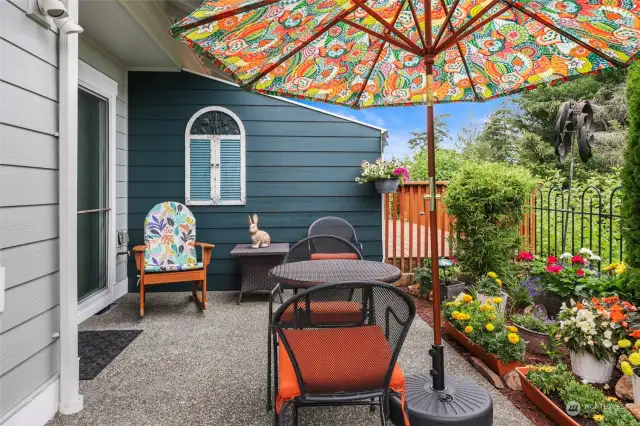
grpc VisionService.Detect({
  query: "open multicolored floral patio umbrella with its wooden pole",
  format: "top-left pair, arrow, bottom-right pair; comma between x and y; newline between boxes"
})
170,0 -> 640,422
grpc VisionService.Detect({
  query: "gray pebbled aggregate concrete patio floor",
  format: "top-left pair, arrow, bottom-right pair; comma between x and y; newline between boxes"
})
48,292 -> 531,426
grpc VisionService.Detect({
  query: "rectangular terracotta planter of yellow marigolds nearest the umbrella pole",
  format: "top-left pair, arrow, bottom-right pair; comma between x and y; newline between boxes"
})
442,294 -> 525,376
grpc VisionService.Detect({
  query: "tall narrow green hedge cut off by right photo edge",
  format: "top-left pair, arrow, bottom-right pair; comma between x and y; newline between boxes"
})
622,64 -> 640,267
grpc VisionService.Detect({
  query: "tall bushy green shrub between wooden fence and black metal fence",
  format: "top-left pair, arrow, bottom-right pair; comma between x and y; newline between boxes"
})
444,163 -> 535,277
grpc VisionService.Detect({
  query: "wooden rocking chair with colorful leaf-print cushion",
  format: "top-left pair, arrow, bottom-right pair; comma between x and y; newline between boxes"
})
133,201 -> 215,318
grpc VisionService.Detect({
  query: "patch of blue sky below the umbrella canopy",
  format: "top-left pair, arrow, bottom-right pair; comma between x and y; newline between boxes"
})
305,99 -> 503,158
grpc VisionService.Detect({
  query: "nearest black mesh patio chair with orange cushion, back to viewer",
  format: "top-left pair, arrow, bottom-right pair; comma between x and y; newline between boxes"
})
272,281 -> 416,426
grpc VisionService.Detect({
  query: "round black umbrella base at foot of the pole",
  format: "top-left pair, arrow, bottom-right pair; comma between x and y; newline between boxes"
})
389,374 -> 493,426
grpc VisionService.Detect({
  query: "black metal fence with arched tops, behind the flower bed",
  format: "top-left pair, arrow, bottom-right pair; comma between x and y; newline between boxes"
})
521,186 -> 624,266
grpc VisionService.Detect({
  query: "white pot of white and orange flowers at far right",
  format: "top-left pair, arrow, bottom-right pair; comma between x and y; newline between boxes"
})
557,296 -> 636,383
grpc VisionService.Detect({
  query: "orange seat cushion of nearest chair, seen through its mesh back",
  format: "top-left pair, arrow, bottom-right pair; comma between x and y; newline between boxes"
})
276,325 -> 405,411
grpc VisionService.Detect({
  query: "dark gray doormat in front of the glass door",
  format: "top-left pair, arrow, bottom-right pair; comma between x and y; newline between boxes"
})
78,330 -> 142,380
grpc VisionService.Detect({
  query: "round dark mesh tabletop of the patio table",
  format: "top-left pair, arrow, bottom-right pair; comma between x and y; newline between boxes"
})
269,260 -> 401,288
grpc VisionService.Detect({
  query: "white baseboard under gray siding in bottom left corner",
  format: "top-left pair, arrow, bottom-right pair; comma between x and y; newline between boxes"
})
0,373 -> 60,426
